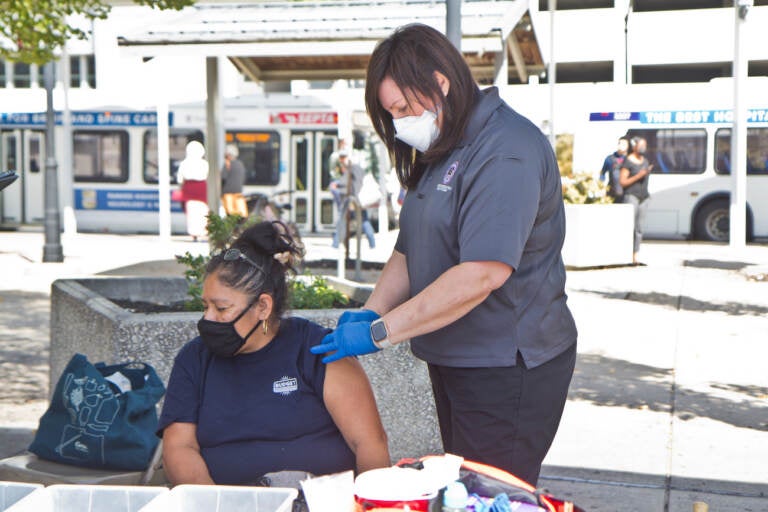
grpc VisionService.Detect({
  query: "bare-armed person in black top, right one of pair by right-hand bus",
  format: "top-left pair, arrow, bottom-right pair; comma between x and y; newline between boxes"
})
619,137 -> 653,265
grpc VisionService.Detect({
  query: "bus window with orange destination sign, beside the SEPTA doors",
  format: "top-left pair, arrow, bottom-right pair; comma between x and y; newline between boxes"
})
225,131 -> 280,185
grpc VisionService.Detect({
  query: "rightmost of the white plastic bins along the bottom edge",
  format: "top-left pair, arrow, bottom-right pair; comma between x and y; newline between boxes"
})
141,485 -> 299,512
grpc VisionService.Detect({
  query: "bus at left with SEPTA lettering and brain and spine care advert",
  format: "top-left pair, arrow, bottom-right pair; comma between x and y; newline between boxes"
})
0,94 -> 384,233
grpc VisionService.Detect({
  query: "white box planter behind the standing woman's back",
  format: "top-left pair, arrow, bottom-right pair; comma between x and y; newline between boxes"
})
562,204 -> 634,268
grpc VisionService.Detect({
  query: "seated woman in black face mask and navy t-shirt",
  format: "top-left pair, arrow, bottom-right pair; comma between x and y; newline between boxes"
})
158,222 -> 390,485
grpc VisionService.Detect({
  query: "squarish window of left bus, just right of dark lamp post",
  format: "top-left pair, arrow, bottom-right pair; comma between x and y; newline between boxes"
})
72,130 -> 128,183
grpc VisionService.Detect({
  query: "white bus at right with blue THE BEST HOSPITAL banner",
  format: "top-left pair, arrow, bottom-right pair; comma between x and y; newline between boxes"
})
574,108 -> 768,241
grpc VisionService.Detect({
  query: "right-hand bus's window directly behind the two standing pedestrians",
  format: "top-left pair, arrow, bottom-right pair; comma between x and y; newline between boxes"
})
627,128 -> 707,174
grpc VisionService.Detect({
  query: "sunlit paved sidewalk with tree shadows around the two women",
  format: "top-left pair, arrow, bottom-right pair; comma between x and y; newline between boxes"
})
0,231 -> 768,512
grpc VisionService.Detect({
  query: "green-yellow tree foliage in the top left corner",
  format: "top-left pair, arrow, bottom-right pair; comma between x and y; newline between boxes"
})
0,0 -> 195,64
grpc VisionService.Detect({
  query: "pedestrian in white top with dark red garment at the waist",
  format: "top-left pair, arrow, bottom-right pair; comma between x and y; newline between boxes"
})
176,140 -> 210,242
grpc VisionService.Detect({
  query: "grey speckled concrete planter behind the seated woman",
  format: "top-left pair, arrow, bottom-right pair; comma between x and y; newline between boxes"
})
50,277 -> 442,462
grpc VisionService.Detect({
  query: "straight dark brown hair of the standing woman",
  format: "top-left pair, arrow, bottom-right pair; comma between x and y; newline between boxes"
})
365,23 -> 479,188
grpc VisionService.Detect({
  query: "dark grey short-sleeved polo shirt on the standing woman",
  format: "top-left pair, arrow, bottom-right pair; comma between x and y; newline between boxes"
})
395,87 -> 576,368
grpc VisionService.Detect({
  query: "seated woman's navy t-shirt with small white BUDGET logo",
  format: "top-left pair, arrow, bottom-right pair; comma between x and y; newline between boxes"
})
159,318 -> 355,485
